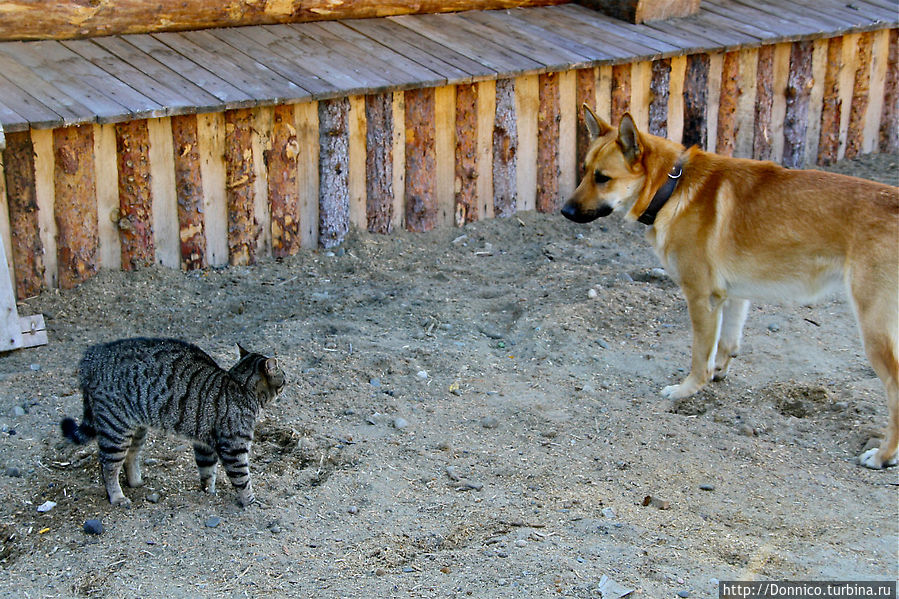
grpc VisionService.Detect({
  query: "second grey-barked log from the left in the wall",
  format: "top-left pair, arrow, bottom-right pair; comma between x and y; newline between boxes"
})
365,92 -> 395,233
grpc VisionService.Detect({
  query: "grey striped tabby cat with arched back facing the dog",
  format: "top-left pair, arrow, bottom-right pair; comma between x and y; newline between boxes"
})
62,338 -> 284,507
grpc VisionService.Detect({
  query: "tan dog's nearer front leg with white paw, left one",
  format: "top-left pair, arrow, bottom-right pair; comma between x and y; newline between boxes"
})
662,289 -> 725,399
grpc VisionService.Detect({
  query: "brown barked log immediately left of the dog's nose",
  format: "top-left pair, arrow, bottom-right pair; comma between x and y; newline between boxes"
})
536,73 -> 562,212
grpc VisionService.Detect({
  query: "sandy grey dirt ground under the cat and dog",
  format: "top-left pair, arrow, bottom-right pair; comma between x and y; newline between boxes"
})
0,155 -> 899,599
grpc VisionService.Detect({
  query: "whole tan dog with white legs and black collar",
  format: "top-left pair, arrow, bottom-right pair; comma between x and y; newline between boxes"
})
562,105 -> 899,469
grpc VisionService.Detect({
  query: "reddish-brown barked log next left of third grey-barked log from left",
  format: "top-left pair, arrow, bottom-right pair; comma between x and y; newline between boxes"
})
454,83 -> 479,227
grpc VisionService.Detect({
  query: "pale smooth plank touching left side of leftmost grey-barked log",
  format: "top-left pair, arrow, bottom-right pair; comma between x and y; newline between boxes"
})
294,102 -> 321,248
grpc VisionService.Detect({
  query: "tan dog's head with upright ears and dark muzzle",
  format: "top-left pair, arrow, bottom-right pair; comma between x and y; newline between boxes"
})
562,104 -> 647,223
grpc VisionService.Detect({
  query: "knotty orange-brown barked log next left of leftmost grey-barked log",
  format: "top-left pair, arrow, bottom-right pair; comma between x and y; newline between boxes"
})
265,105 -> 300,258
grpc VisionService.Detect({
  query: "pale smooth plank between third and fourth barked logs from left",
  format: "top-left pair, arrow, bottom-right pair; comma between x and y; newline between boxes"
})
148,117 -> 181,268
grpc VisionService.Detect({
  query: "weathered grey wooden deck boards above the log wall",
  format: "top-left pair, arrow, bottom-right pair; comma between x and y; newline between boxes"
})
0,0 -> 897,133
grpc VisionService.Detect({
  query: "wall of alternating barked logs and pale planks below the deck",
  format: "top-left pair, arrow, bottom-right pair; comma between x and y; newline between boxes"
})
0,30 -> 899,299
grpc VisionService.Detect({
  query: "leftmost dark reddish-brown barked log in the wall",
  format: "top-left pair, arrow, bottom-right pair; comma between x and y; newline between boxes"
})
3,131 -> 44,300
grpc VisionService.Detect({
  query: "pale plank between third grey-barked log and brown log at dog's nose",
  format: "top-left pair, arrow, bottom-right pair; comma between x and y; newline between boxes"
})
515,75 -> 540,211
